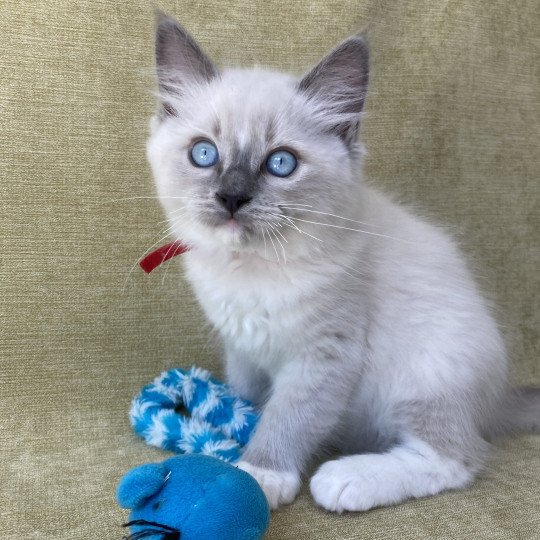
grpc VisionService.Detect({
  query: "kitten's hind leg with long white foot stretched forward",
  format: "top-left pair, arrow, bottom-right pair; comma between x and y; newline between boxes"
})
311,398 -> 487,512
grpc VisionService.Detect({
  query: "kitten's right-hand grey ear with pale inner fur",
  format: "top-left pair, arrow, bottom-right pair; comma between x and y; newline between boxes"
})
299,36 -> 369,145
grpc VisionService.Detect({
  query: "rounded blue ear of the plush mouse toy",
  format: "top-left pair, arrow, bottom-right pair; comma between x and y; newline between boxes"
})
116,463 -> 169,508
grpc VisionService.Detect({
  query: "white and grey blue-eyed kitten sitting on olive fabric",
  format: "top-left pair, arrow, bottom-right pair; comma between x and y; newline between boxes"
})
148,12 -> 540,512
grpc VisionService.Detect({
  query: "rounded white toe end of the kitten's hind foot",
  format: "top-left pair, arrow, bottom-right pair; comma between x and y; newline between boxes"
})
310,458 -> 390,513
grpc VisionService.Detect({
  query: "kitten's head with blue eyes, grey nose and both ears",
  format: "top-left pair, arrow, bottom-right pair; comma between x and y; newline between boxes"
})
148,17 -> 368,255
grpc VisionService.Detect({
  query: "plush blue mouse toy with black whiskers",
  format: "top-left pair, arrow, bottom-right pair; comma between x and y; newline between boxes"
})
117,454 -> 270,540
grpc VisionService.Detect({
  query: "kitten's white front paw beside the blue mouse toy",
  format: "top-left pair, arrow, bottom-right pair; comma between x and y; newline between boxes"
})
236,461 -> 300,510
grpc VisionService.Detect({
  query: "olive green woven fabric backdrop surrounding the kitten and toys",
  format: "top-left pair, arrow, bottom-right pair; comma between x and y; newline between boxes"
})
0,0 -> 540,540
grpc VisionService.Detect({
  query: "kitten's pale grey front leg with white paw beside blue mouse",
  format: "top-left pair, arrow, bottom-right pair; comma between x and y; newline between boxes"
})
238,358 -> 355,508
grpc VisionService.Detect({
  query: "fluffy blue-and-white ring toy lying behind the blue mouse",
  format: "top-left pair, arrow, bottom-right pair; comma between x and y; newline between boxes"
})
129,366 -> 258,462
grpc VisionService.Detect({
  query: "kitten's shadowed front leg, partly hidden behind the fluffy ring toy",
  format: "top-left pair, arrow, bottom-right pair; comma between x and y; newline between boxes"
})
225,349 -> 270,407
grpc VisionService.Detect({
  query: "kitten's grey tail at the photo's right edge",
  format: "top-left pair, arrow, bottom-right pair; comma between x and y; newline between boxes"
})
494,387 -> 540,435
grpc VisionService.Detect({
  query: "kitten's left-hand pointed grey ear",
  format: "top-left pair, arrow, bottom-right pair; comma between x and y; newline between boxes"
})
156,12 -> 218,115
